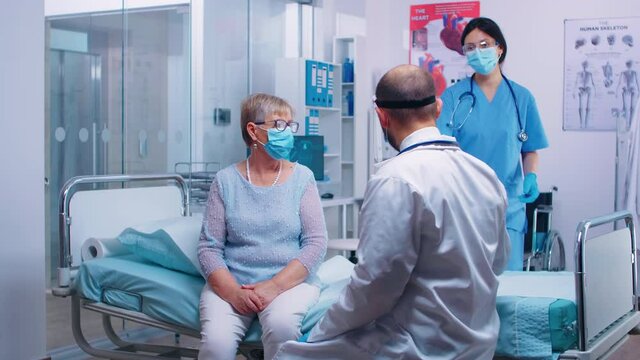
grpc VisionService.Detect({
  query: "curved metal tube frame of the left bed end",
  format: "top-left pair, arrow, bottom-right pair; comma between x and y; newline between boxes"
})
52,174 -> 189,296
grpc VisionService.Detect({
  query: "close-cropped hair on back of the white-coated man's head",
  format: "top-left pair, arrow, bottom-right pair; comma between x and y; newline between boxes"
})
376,65 -> 438,122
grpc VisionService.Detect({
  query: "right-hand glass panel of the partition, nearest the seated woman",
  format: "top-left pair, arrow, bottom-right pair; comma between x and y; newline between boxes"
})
122,0 -> 191,174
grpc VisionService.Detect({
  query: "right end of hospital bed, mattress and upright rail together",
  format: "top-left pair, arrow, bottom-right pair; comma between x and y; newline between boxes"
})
496,211 -> 640,360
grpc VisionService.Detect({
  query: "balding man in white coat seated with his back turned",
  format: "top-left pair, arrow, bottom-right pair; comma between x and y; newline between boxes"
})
275,65 -> 510,360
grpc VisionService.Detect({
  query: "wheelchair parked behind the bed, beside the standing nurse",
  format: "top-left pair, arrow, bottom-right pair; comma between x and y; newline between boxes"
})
523,186 -> 566,271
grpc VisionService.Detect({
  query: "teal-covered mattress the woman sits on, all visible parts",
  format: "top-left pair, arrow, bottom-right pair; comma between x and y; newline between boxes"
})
76,255 -> 576,357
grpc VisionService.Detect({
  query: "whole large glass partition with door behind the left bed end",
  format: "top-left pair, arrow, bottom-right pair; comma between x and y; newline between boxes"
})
46,1 -> 191,286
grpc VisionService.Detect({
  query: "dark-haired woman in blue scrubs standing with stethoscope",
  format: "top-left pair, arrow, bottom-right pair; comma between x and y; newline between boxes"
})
437,17 -> 549,270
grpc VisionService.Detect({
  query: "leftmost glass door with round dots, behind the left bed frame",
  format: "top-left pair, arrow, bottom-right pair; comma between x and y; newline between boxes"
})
46,49 -> 104,286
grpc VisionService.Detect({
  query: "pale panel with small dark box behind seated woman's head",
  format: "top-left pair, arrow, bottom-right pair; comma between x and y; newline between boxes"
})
189,0 -> 249,208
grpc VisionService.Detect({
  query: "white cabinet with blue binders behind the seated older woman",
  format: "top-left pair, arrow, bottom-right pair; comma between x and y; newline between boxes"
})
275,58 -> 344,197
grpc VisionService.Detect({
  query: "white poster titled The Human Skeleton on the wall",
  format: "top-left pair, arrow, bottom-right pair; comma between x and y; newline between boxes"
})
563,17 -> 640,130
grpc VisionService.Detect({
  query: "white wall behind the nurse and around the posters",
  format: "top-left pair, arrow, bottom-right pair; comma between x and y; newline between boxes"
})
366,0 -> 640,267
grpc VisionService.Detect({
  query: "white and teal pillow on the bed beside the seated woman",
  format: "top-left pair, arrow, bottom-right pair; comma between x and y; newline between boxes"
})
118,214 -> 202,275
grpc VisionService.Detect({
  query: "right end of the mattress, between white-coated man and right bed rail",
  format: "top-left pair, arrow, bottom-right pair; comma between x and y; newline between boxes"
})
496,272 -> 577,358
